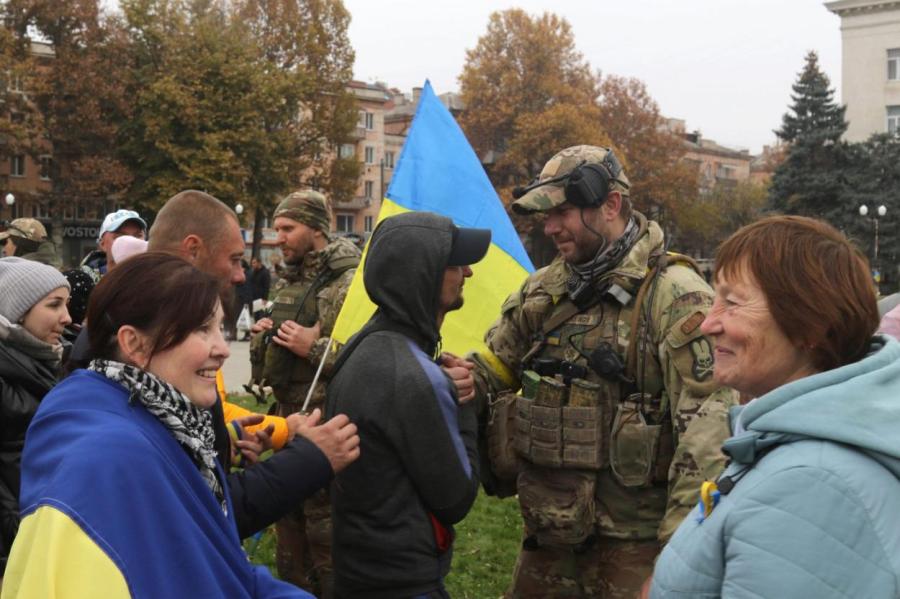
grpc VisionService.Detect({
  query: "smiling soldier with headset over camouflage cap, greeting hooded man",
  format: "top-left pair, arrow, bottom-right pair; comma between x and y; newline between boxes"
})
471,146 -> 735,597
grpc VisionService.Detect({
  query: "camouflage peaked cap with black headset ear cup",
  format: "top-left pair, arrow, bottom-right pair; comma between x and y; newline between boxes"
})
512,146 -> 631,214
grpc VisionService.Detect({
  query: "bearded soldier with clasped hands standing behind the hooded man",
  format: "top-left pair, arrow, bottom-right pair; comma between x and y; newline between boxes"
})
251,190 -> 360,597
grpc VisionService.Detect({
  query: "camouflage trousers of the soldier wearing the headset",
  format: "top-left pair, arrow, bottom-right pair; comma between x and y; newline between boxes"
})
506,538 -> 659,599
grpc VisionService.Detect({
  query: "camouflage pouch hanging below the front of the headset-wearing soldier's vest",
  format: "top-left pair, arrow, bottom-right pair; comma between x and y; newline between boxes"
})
518,468 -> 596,548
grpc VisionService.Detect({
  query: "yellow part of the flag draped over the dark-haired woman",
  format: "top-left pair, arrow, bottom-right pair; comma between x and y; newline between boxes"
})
0,506 -> 131,599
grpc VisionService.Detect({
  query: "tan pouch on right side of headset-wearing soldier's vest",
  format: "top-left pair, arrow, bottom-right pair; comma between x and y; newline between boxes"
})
609,394 -> 672,488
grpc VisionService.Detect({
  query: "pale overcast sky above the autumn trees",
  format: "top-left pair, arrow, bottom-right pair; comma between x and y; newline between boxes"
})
344,0 -> 841,153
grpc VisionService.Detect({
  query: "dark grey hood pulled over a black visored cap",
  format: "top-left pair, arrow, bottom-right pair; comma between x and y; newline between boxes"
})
363,212 -> 490,348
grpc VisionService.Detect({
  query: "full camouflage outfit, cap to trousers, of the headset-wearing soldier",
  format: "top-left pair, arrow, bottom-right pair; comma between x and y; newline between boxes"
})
472,146 -> 735,597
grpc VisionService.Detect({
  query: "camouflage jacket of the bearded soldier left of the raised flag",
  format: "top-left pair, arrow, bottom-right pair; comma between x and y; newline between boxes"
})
256,237 -> 360,409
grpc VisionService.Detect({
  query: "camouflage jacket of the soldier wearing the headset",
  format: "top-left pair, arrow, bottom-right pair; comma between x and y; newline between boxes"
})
471,215 -> 736,542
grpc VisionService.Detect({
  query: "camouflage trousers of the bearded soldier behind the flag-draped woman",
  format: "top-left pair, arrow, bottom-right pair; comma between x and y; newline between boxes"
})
275,490 -> 334,599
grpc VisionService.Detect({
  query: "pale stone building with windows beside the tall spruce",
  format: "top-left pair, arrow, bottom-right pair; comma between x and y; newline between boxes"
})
825,0 -> 900,142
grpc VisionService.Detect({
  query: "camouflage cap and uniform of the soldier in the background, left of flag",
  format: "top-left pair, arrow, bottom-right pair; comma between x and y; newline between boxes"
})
251,192 -> 360,597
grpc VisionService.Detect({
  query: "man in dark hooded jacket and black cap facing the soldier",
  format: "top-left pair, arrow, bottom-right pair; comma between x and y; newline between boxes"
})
326,212 -> 490,598
